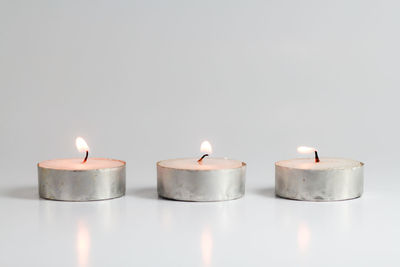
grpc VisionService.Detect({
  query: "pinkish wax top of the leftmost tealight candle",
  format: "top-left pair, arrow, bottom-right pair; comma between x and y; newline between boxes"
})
39,158 -> 125,170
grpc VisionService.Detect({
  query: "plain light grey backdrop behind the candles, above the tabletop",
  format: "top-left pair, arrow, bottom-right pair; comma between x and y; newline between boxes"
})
0,0 -> 400,266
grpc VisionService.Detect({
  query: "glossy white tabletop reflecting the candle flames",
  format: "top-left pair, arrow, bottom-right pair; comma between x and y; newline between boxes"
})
0,166 -> 400,267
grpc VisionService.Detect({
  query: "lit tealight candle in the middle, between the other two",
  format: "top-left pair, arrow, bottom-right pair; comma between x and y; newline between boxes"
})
157,141 -> 246,201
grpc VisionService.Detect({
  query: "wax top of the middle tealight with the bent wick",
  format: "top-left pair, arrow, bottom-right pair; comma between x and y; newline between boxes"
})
159,157 -> 242,170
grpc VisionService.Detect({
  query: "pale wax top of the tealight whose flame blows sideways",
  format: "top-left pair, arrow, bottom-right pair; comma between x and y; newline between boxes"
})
276,158 -> 362,170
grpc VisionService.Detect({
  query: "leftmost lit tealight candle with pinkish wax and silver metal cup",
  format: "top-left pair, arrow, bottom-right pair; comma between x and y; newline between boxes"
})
38,137 -> 126,201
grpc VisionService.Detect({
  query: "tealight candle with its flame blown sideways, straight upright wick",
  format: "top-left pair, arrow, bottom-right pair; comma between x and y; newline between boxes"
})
275,147 -> 364,201
